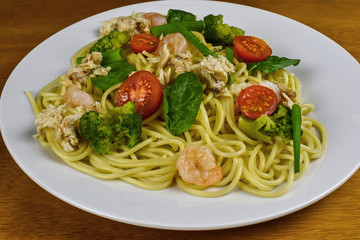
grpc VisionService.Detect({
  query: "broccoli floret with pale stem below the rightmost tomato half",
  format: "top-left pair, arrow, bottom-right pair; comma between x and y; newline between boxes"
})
238,104 -> 293,143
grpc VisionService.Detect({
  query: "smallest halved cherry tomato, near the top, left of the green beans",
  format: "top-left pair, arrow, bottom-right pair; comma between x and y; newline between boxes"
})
130,33 -> 160,53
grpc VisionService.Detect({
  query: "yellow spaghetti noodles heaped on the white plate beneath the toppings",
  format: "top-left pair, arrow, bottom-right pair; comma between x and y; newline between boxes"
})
27,12 -> 327,197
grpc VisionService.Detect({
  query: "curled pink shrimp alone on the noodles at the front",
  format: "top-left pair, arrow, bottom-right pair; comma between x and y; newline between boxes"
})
176,145 -> 222,187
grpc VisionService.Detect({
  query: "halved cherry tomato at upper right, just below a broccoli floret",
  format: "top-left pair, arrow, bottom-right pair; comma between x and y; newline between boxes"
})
233,36 -> 272,63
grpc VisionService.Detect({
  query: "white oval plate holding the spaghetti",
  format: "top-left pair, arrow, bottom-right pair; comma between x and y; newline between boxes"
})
0,1 -> 360,230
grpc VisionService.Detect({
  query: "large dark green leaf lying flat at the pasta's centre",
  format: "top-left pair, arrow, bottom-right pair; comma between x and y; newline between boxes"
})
163,72 -> 203,136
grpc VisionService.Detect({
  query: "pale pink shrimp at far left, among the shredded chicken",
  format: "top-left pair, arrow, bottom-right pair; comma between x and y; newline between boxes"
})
64,85 -> 94,109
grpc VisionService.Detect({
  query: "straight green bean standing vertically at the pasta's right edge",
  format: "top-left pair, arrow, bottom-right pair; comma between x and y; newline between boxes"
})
292,104 -> 301,173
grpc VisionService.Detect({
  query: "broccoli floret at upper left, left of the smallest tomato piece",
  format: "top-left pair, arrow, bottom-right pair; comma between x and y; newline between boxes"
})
90,28 -> 130,52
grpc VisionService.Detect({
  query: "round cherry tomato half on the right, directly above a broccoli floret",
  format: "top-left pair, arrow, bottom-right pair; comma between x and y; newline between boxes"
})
238,85 -> 278,119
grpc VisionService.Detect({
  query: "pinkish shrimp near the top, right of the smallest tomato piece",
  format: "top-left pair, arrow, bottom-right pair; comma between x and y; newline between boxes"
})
154,33 -> 189,56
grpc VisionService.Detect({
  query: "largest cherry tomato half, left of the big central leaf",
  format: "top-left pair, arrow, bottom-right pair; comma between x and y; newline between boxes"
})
115,70 -> 163,119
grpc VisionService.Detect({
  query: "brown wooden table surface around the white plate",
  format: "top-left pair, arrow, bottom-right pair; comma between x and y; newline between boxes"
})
0,0 -> 360,239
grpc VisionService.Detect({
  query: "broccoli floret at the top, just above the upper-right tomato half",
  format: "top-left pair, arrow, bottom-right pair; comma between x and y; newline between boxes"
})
204,14 -> 245,46
